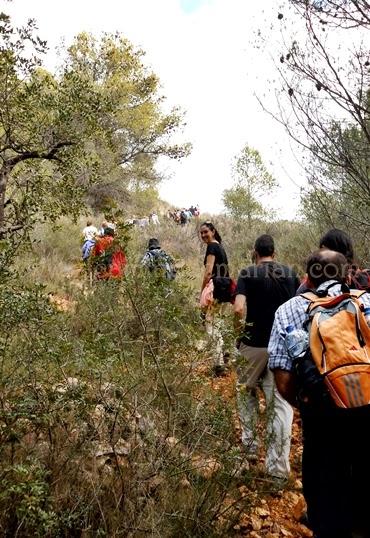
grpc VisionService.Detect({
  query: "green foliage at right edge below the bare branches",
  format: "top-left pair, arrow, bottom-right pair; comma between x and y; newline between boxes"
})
302,91 -> 370,266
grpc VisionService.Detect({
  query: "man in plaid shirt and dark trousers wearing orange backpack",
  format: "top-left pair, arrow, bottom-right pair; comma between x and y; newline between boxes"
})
268,250 -> 370,538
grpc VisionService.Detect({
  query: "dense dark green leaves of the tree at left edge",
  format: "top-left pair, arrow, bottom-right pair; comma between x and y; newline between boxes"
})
0,14 -> 101,230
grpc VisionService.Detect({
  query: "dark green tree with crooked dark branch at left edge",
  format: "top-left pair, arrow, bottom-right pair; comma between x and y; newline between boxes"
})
0,13 -> 87,238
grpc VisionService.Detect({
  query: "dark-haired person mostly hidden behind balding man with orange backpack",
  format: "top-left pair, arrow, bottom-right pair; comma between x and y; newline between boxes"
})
297,228 -> 370,295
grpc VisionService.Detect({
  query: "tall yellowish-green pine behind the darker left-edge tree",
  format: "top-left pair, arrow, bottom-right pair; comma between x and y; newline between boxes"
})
65,33 -> 190,214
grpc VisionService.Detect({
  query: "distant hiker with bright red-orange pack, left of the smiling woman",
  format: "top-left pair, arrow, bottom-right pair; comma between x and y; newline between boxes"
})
92,226 -> 127,280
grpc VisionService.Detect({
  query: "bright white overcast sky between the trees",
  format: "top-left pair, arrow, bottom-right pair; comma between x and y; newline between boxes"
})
5,0 -> 304,218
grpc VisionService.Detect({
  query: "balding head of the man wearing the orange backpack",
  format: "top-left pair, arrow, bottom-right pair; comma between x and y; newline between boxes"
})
306,250 -> 349,288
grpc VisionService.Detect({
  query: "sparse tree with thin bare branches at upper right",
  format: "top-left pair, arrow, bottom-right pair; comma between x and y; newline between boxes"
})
260,0 -> 370,233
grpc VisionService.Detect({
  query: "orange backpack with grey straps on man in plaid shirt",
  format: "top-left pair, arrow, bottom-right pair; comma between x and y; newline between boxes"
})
302,290 -> 370,408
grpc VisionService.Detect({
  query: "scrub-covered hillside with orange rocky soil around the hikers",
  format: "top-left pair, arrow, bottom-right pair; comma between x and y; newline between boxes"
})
0,219 -> 318,538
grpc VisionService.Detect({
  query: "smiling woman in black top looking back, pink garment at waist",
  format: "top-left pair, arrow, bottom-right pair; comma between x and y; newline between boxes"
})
199,221 -> 230,376
